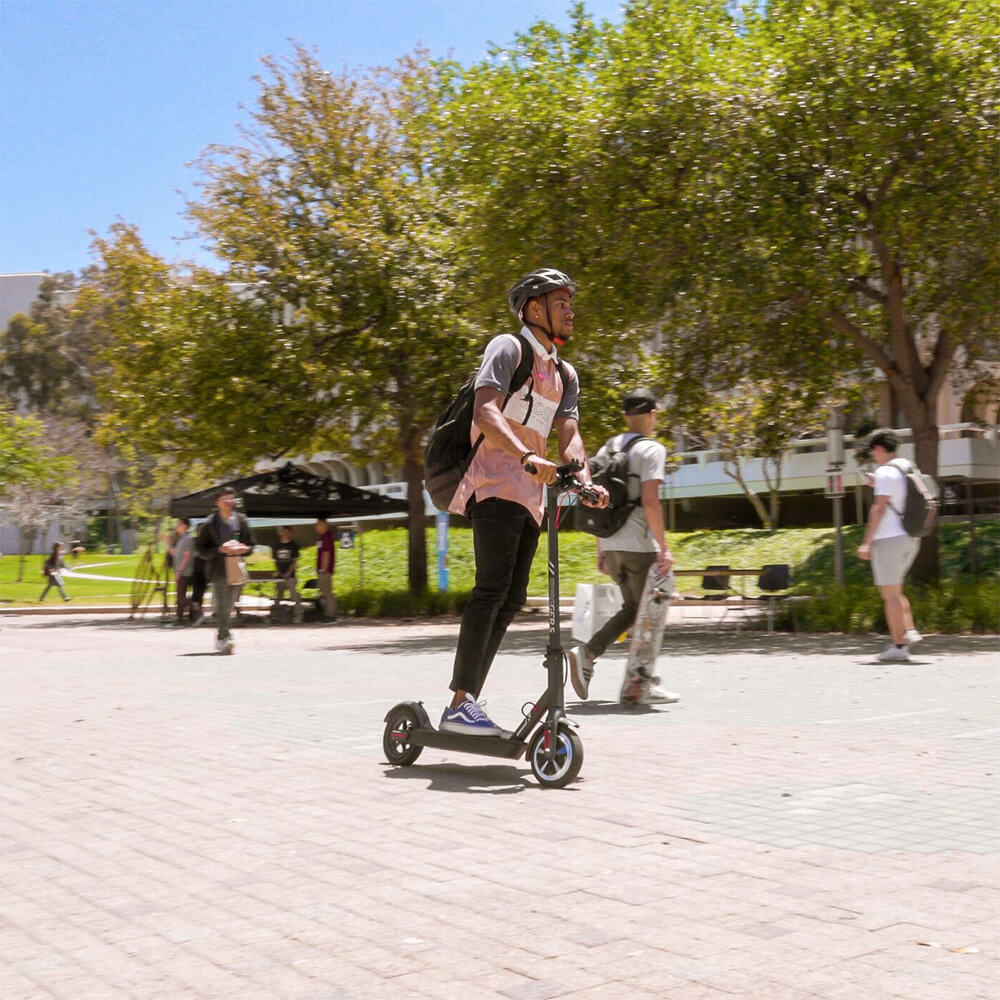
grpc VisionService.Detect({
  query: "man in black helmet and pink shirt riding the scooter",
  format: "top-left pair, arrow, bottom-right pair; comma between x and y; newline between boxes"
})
440,267 -> 608,736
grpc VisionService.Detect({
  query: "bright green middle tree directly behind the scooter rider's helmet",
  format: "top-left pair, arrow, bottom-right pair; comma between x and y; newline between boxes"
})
435,0 -> 748,440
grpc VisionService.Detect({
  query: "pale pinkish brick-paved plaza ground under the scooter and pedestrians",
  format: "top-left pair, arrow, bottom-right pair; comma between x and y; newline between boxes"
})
0,617 -> 1000,1000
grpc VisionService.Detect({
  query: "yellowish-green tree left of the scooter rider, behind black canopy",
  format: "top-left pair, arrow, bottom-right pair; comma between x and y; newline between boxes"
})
87,46 -> 484,591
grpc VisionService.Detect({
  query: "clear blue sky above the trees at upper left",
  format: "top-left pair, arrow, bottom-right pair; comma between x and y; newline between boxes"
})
0,0 -> 620,274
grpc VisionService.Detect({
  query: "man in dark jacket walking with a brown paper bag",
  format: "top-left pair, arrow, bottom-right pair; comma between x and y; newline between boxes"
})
195,486 -> 254,654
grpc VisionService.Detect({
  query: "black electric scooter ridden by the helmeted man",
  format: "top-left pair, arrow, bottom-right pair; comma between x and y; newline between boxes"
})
382,461 -> 598,788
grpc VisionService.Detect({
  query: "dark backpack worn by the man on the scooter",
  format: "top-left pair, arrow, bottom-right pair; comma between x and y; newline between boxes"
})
424,333 -> 566,510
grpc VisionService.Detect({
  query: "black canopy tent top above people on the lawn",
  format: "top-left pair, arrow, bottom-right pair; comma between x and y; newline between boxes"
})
170,462 -> 409,520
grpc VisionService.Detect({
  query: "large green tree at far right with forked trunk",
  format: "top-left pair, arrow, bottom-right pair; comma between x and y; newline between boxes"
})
699,0 -> 1000,474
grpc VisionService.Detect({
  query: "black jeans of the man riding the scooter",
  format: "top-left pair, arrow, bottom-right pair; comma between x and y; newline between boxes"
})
451,497 -> 539,698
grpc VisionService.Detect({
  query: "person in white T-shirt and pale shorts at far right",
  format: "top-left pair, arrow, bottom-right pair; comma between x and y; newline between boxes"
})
858,430 -> 923,662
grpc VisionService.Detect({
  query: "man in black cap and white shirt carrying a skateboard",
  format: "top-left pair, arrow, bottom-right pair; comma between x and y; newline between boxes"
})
569,388 -> 680,705
